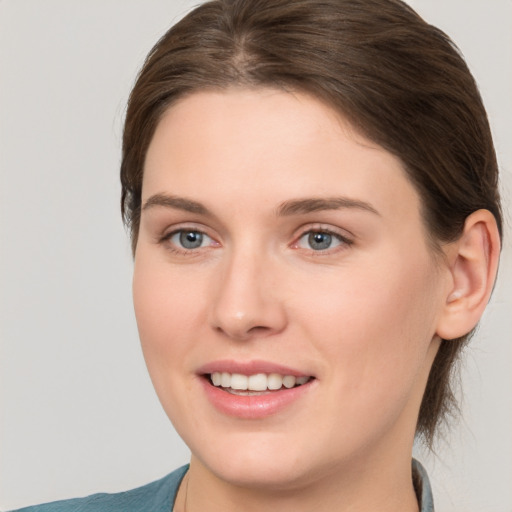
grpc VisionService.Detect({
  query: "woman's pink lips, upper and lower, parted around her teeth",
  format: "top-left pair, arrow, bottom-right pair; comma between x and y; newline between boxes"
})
198,360 -> 316,420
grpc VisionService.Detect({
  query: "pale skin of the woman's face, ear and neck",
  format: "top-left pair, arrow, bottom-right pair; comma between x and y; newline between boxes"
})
133,89 -> 499,512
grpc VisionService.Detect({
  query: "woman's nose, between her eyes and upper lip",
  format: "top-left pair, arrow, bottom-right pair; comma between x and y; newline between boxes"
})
210,248 -> 287,341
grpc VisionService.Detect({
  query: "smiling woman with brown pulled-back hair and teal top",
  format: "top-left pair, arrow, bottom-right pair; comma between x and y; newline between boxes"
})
7,0 -> 501,512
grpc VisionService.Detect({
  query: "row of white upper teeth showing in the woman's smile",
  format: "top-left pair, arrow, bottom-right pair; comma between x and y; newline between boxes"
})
210,372 -> 310,392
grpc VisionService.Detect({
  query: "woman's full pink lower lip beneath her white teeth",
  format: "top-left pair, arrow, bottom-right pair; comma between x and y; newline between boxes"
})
201,377 -> 314,420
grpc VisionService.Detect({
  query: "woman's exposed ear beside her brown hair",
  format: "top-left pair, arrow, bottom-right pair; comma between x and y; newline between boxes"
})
436,210 -> 500,340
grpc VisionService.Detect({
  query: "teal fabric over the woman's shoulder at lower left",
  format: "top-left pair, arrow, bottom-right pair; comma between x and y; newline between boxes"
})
9,466 -> 188,512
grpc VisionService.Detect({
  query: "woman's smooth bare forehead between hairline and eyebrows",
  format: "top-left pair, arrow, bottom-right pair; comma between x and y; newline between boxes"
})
143,89 -> 419,222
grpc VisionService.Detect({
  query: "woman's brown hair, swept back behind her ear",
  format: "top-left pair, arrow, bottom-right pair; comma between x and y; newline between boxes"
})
121,0 -> 502,445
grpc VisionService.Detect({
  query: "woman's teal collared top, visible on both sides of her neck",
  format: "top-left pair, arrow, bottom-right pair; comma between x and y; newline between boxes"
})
9,459 -> 434,512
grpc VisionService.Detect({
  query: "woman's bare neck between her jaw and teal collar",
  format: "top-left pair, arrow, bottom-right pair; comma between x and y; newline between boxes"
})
174,455 -> 418,512
